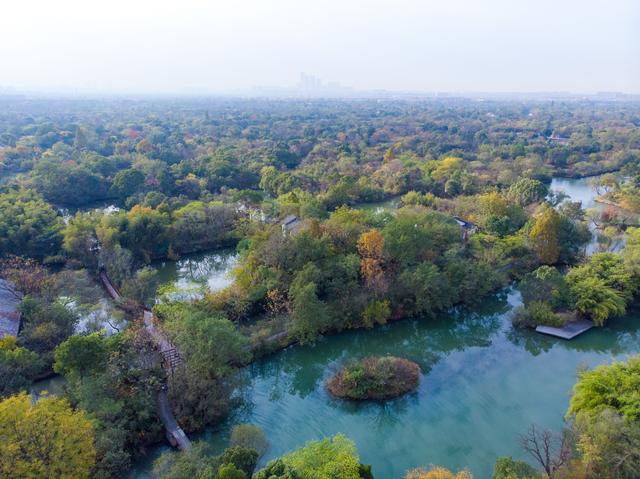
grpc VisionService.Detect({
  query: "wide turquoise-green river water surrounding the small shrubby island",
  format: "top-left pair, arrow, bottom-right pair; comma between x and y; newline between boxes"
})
131,179 -> 640,479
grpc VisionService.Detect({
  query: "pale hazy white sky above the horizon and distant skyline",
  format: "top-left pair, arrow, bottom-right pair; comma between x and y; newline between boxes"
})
0,0 -> 640,94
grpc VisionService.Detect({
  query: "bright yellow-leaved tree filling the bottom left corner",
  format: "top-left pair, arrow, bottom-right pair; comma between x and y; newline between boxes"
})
0,393 -> 96,479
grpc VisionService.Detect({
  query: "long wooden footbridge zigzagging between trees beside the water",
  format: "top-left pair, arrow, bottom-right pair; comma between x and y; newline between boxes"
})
100,271 -> 191,451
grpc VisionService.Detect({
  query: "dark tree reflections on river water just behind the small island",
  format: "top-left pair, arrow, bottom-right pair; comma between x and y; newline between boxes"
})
250,291 -> 510,399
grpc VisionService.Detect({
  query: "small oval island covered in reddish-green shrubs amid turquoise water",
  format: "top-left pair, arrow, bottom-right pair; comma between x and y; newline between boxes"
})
327,356 -> 420,400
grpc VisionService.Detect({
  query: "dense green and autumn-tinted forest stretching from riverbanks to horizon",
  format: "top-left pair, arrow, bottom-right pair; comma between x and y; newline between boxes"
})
0,96 -> 640,479
